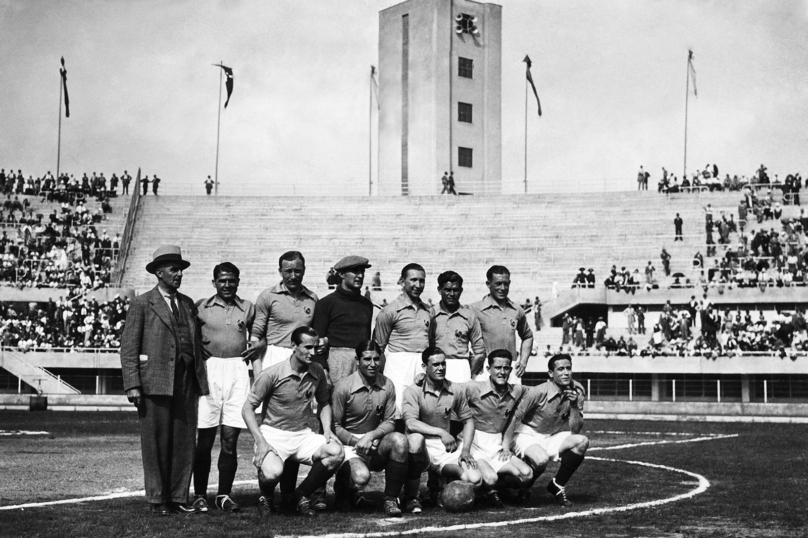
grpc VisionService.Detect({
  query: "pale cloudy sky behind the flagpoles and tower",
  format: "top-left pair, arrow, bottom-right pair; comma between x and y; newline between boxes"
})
0,0 -> 808,196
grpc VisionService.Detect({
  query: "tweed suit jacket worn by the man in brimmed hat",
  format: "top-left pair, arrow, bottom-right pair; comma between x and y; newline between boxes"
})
121,286 -> 209,396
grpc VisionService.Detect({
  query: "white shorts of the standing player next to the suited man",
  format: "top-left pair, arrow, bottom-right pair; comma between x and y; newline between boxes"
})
197,357 -> 250,428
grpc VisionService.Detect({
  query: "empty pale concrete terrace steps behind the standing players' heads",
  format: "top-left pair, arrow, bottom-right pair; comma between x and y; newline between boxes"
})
118,191 -> 799,303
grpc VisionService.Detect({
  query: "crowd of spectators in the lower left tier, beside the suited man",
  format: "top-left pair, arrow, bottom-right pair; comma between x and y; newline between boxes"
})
0,295 -> 129,352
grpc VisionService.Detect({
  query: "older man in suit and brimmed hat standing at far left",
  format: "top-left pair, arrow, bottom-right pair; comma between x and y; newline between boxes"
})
121,245 -> 208,516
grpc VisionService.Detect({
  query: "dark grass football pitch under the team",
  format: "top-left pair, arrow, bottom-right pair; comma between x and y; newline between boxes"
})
0,411 -> 808,538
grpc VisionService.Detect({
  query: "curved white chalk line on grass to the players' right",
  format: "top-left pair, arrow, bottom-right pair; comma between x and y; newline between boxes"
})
276,456 -> 710,538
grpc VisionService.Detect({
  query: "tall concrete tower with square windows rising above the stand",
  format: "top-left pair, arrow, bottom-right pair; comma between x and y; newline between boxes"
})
378,0 -> 502,196
